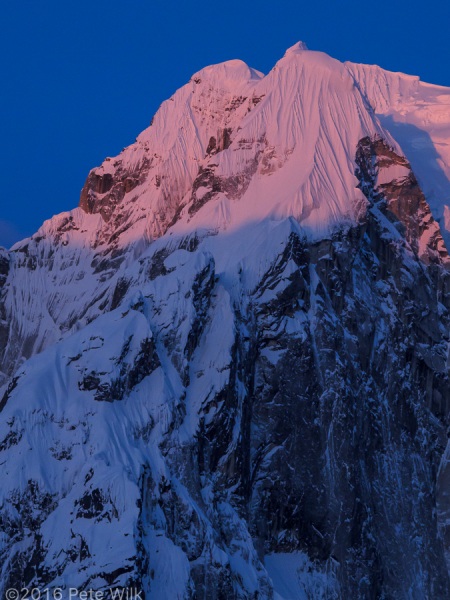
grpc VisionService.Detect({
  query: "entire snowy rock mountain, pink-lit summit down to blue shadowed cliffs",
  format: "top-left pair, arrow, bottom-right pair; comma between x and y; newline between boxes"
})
0,43 -> 450,600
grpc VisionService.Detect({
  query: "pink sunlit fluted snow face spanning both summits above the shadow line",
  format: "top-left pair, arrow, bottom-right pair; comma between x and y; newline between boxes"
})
80,43 -> 394,244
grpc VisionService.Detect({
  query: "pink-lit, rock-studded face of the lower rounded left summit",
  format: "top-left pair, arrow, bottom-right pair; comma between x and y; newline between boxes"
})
80,54 -> 262,246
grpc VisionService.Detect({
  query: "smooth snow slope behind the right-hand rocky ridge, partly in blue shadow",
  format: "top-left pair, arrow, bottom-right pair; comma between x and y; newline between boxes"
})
346,63 -> 450,246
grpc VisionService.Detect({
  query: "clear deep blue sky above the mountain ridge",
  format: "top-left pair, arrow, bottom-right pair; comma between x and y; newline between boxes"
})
0,0 -> 450,246
